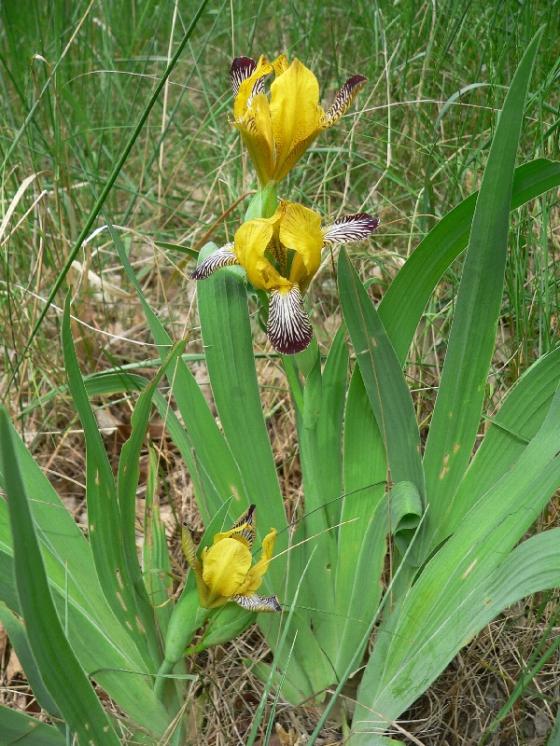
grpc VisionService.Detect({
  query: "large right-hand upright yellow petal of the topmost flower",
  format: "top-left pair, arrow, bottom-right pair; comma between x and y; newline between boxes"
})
270,60 -> 324,181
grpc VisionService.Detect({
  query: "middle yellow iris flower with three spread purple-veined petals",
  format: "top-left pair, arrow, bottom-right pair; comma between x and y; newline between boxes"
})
192,202 -> 379,355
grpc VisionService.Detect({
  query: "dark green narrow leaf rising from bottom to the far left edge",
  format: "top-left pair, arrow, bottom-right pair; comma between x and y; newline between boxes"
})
0,409 -> 120,746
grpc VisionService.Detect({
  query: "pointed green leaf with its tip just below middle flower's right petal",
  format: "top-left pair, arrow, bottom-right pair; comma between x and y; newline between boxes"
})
338,251 -> 424,506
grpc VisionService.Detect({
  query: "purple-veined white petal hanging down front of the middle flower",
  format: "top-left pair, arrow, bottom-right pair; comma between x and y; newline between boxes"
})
266,285 -> 313,355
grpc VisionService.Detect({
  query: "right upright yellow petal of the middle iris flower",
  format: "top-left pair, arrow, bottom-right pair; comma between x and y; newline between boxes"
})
280,202 -> 324,292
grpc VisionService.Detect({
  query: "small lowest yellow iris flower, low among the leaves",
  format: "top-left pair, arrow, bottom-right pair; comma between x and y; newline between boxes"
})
182,505 -> 281,611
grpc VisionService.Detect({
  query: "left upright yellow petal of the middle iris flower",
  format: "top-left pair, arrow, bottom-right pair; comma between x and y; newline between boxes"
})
234,211 -> 291,290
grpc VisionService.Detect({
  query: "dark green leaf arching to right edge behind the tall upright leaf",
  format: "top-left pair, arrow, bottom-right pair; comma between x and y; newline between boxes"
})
378,158 -> 560,364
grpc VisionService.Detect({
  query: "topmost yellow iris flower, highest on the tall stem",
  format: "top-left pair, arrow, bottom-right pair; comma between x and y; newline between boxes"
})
230,55 -> 366,184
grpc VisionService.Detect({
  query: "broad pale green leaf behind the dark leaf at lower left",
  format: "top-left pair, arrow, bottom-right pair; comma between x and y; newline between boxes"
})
0,424 -> 168,733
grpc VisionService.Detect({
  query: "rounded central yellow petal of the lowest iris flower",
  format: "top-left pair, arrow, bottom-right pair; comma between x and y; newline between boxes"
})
202,539 -> 251,599
